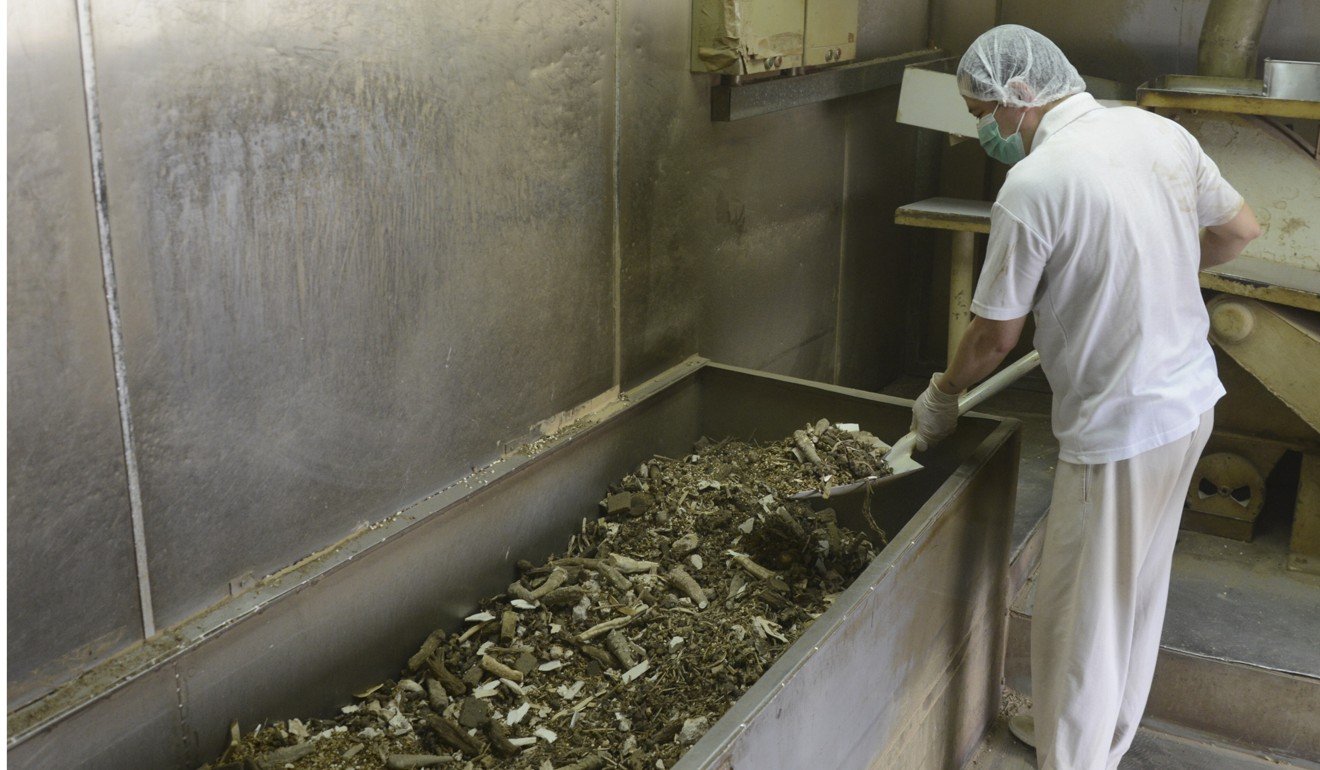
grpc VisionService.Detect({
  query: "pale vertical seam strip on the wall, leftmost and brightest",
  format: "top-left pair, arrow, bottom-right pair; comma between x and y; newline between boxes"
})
77,0 -> 156,639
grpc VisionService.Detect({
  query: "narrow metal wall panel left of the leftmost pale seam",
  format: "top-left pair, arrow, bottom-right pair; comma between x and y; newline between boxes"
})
7,0 -> 143,708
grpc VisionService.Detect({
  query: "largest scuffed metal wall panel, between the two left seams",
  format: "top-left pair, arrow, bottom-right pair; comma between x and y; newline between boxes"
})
92,0 -> 614,626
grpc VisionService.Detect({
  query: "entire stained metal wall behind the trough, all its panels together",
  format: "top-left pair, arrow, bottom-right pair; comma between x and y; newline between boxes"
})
9,0 -> 928,708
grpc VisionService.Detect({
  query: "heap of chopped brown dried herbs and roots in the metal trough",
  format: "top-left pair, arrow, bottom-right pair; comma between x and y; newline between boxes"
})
206,420 -> 888,770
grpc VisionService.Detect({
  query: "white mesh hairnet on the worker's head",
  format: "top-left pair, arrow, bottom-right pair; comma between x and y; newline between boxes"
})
958,24 -> 1086,107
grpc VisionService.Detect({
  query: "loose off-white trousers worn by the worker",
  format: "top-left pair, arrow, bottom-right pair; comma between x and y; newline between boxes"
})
1031,409 -> 1214,770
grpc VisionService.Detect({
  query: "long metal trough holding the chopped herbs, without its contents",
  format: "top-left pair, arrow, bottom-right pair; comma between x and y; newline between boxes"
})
8,359 -> 1019,770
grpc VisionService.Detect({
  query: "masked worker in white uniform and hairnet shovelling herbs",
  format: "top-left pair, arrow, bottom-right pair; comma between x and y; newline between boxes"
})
913,25 -> 1259,770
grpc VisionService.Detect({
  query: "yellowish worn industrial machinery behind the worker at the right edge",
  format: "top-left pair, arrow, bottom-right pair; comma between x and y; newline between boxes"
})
1137,0 -> 1320,572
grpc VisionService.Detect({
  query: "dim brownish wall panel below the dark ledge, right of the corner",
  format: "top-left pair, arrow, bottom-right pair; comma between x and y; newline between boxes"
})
691,104 -> 843,382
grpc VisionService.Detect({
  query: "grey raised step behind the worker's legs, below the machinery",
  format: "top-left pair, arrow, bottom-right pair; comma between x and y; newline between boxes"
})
1005,532 -> 1320,761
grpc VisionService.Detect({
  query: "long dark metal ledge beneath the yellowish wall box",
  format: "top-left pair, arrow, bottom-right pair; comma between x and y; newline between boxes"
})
710,48 -> 945,123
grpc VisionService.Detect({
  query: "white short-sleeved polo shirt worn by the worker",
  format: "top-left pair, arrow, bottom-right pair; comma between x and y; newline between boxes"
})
972,94 -> 1242,464
